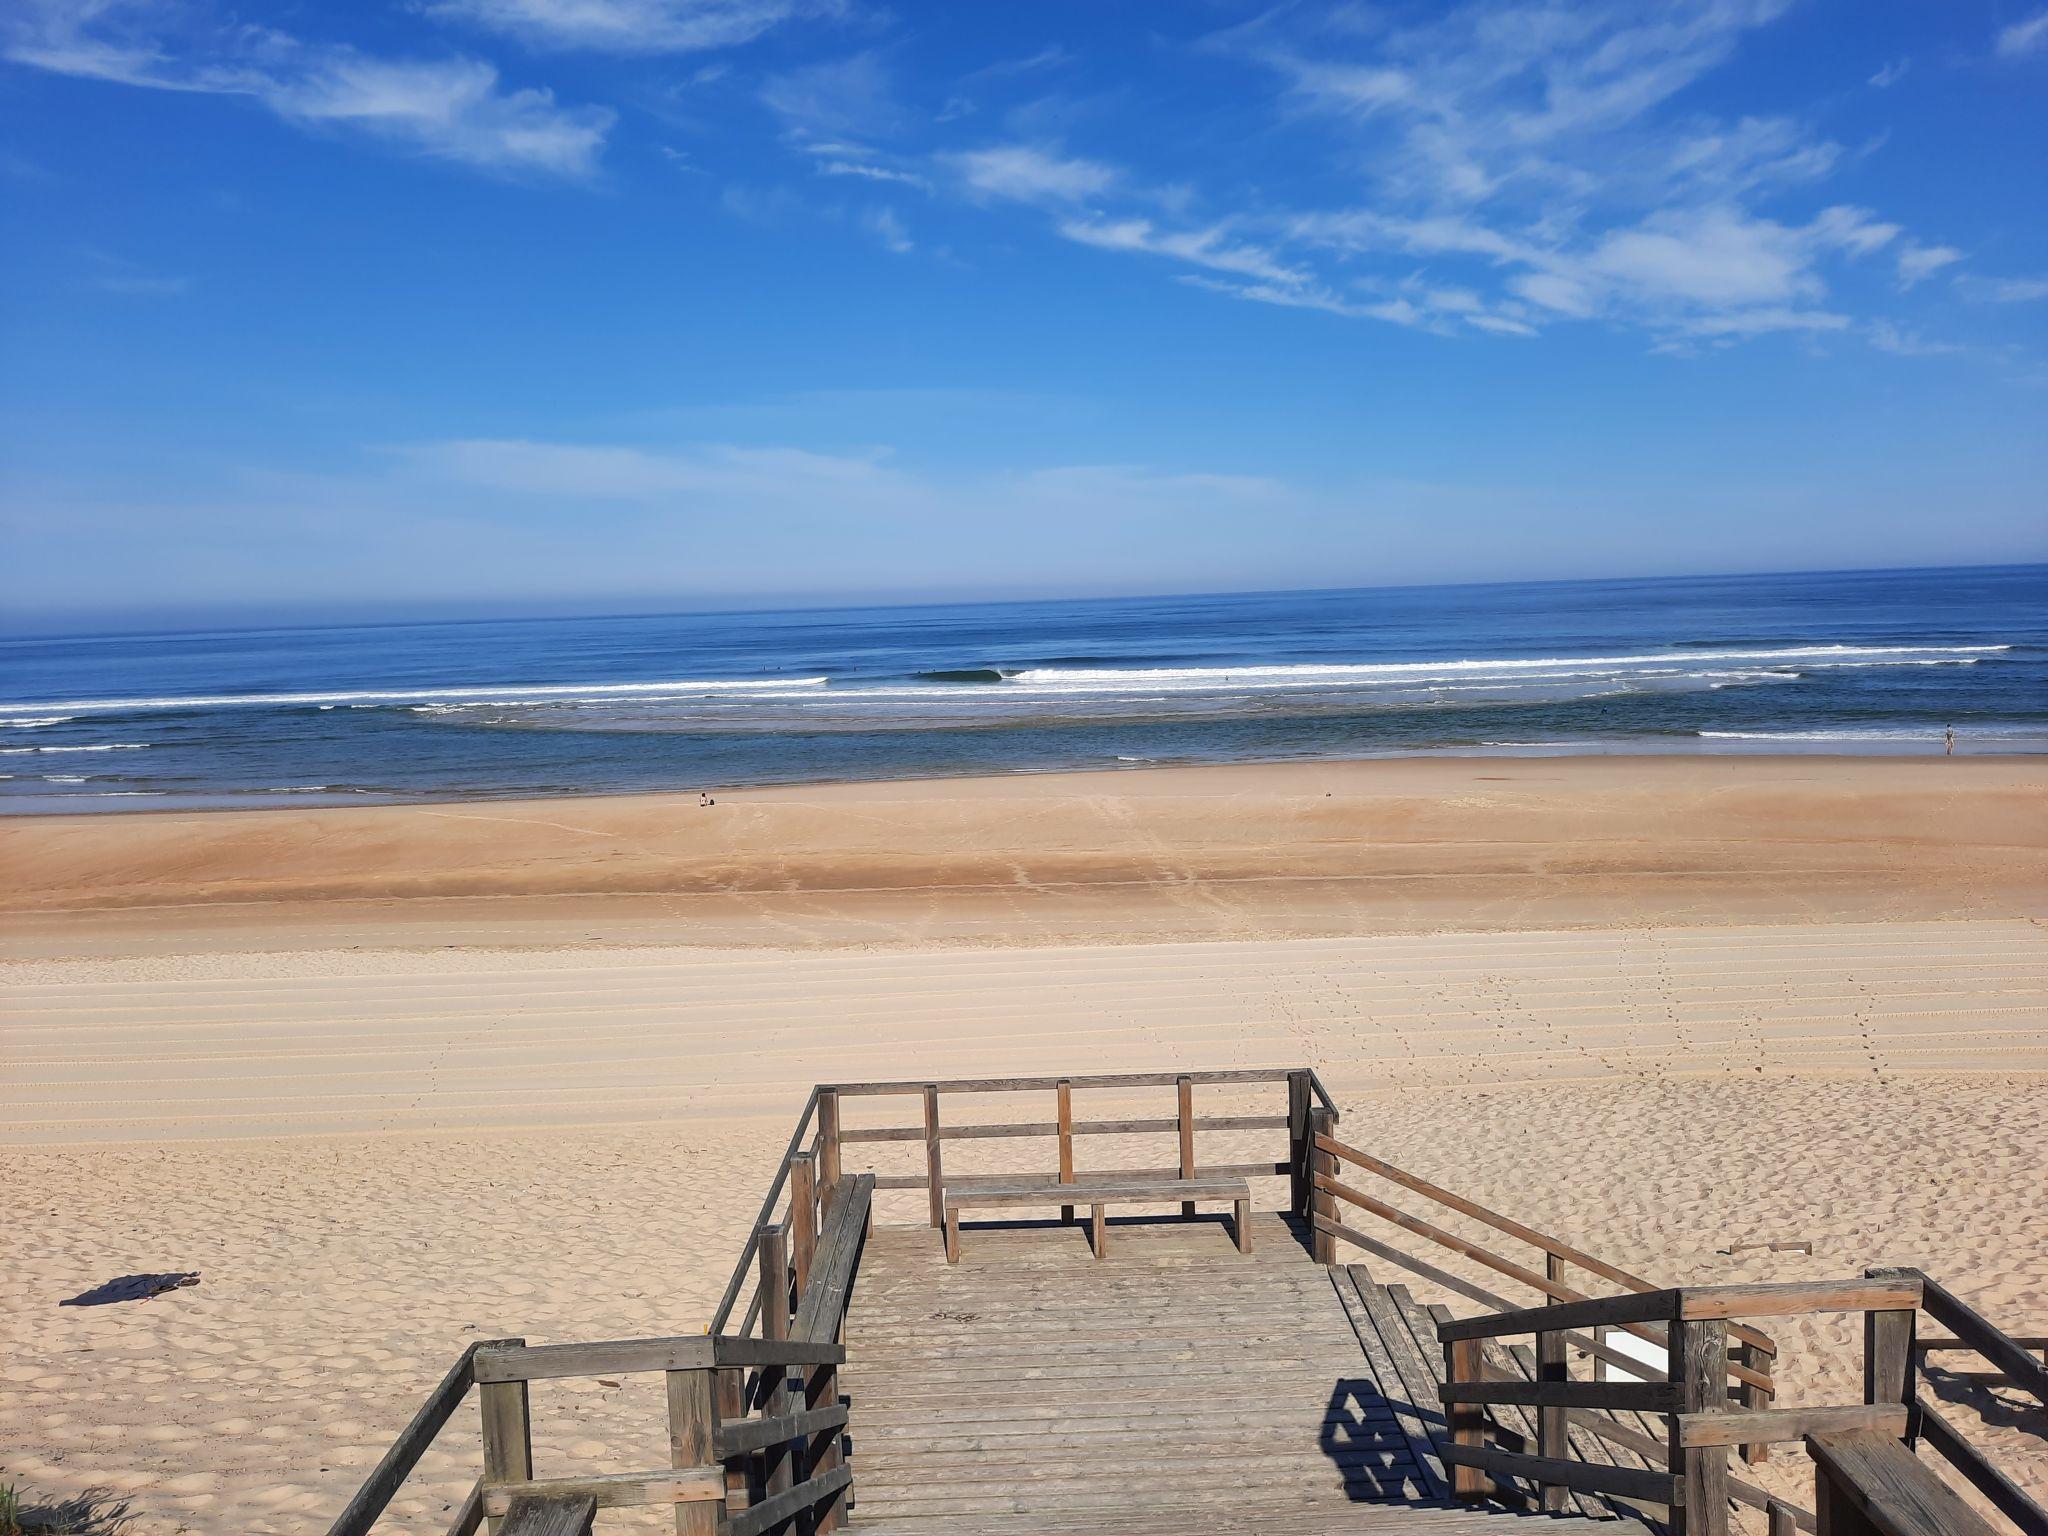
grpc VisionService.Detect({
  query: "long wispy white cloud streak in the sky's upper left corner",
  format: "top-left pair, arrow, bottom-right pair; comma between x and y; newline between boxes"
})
4,0 -> 614,178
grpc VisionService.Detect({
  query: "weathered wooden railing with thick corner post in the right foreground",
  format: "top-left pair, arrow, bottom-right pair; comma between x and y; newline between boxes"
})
1438,1278 -> 1921,1536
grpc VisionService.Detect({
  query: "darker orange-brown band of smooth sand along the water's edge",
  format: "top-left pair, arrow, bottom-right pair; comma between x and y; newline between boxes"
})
0,754 -> 2048,958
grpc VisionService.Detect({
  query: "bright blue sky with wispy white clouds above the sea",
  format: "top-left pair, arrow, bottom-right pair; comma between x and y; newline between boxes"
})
0,0 -> 2048,627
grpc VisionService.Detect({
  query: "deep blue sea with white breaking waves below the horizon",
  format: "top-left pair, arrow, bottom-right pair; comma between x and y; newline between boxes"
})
0,565 -> 2048,813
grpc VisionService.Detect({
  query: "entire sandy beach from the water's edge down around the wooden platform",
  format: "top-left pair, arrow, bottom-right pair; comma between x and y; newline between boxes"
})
0,760 -> 2048,1532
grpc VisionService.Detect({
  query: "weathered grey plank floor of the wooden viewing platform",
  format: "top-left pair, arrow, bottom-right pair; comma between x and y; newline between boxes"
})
842,1212 -> 1646,1536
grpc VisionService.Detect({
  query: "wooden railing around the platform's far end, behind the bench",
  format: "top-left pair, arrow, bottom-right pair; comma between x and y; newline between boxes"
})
711,1067 -> 1337,1337
